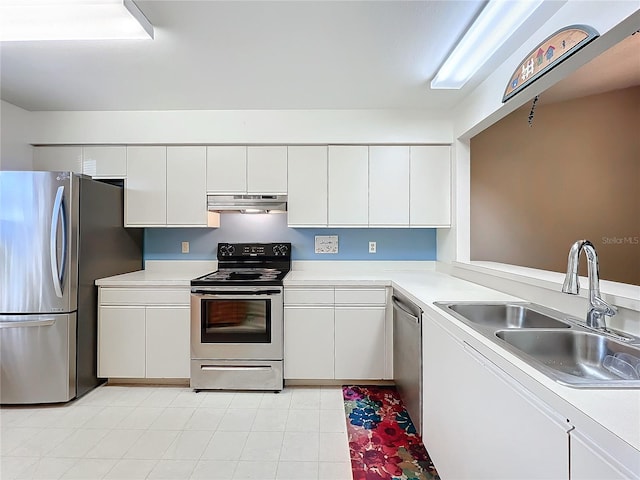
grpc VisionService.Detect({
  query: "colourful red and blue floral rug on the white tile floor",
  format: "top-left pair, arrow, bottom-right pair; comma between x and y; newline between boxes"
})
342,386 -> 440,480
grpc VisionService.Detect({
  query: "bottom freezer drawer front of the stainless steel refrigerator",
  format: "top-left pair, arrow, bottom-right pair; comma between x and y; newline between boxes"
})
0,313 -> 76,405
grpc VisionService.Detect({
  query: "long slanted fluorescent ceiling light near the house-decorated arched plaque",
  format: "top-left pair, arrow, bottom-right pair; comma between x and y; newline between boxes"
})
431,0 -> 542,89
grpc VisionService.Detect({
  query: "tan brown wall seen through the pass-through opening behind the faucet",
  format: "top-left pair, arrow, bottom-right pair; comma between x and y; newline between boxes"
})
471,87 -> 640,285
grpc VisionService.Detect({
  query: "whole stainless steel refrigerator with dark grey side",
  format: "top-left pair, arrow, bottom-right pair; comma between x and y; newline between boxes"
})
0,171 -> 142,404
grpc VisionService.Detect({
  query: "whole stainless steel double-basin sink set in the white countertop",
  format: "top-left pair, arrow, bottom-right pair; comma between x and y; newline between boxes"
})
435,302 -> 640,389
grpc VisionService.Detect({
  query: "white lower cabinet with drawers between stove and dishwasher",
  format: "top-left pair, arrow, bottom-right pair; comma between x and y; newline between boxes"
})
284,287 -> 392,380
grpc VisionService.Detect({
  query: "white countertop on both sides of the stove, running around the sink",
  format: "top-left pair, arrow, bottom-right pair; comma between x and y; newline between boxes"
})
96,262 -> 640,451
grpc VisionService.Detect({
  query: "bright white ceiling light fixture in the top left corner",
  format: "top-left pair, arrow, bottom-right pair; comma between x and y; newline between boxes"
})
0,0 -> 153,42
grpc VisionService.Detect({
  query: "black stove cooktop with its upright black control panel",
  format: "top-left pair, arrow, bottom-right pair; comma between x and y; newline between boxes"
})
191,243 -> 291,286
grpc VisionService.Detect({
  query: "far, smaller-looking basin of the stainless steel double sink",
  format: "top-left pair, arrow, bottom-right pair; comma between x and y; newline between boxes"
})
448,303 -> 570,328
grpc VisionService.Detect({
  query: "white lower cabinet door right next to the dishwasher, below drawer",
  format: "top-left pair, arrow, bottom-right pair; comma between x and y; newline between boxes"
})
335,306 -> 386,380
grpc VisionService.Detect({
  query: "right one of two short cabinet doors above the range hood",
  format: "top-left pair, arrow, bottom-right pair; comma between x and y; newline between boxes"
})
247,146 -> 287,195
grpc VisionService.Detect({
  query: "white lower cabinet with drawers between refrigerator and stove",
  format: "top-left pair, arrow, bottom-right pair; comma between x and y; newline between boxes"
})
98,287 -> 191,378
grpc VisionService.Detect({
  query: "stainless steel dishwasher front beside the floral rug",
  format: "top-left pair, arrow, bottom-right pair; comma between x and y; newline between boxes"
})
392,291 -> 422,435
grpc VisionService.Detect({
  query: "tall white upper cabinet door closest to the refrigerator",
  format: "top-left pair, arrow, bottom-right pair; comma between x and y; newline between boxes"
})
124,146 -> 167,226
